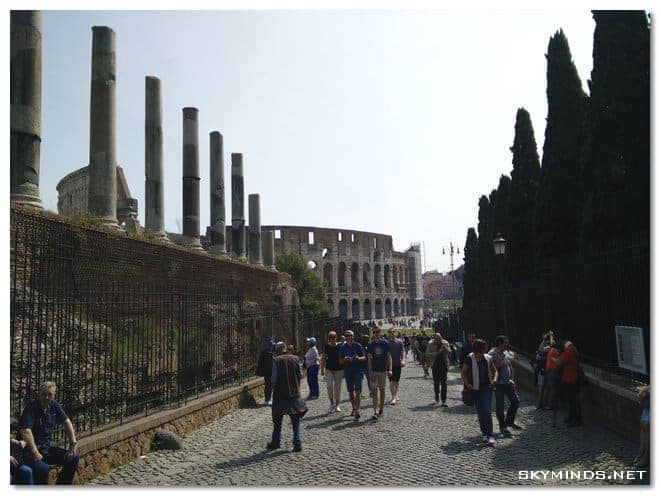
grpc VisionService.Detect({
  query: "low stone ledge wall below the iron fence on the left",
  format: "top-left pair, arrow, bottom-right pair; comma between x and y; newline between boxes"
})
74,378 -> 264,484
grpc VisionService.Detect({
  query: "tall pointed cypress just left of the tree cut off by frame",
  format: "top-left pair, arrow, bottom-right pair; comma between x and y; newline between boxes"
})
535,30 -> 588,264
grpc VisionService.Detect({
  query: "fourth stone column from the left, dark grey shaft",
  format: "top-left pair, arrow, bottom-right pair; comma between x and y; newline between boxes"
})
182,107 -> 202,250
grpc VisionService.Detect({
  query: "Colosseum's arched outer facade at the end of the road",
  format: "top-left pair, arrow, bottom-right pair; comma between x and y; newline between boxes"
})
262,226 -> 423,320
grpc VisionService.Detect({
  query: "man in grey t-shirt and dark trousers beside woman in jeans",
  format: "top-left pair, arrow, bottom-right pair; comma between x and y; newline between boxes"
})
489,335 -> 521,437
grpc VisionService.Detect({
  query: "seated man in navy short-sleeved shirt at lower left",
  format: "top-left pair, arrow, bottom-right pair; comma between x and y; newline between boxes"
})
18,381 -> 80,484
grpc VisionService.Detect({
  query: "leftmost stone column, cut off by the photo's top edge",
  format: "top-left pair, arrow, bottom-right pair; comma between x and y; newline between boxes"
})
9,10 -> 43,208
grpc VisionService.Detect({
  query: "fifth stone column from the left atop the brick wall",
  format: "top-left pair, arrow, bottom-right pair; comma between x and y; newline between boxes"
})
209,131 -> 226,254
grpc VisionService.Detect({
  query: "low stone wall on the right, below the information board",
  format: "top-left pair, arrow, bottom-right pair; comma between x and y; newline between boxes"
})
514,359 -> 641,442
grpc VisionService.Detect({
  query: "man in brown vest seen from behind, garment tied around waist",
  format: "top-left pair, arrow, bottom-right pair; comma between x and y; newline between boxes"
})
266,341 -> 303,451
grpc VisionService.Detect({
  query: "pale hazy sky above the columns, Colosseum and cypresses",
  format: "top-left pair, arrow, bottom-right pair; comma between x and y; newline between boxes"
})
34,9 -> 594,271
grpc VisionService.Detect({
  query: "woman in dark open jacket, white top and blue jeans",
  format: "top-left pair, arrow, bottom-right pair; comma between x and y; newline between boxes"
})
461,339 -> 498,446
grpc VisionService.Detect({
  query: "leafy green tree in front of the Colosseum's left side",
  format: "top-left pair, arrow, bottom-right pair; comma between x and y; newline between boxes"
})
275,253 -> 328,319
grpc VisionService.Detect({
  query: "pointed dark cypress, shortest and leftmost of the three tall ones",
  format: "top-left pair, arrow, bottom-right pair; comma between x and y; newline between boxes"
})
507,108 -> 540,279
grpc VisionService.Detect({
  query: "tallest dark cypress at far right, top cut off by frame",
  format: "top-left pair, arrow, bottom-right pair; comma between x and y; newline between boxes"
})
582,7 -> 650,250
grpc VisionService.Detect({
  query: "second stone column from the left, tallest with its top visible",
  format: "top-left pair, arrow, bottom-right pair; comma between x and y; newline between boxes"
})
87,26 -> 117,227
